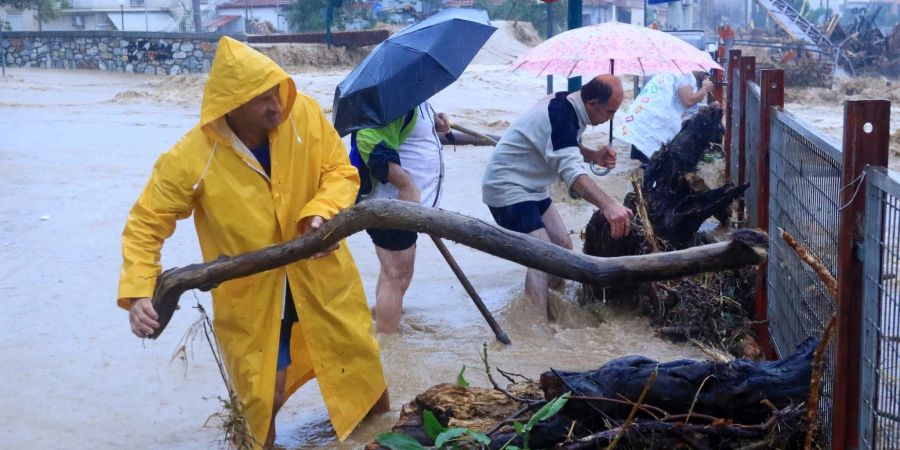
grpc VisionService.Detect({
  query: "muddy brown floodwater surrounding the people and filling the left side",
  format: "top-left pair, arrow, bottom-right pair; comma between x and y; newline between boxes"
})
0,62 -> 892,449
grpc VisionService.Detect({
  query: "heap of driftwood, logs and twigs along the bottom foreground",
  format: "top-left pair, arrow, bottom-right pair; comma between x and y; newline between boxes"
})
366,339 -> 817,450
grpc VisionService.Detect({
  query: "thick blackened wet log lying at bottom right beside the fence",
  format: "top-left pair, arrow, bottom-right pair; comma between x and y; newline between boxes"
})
541,338 -> 818,423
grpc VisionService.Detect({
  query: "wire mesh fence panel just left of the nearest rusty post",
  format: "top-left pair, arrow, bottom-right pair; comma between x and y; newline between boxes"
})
767,111 -> 843,448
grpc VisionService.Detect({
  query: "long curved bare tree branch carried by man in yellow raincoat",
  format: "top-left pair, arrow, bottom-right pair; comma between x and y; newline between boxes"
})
149,199 -> 768,339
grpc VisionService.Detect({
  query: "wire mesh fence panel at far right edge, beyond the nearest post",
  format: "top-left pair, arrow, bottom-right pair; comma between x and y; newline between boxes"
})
859,167 -> 900,450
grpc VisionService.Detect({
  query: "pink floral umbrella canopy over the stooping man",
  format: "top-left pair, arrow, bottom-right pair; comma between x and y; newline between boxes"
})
511,22 -> 722,77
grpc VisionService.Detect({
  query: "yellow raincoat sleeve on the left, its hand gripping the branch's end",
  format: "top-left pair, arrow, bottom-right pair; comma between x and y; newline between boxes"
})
118,151 -> 193,308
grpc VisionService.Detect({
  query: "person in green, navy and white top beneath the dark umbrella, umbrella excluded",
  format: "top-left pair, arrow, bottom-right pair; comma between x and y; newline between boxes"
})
352,101 -> 450,333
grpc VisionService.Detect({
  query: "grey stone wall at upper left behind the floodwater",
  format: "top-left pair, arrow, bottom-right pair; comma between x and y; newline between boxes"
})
0,31 -> 246,75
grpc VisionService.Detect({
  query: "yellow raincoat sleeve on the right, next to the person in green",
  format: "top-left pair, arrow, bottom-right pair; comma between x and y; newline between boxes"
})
297,109 -> 359,224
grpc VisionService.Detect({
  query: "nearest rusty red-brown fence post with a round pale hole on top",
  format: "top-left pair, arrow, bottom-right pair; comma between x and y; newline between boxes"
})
831,100 -> 891,450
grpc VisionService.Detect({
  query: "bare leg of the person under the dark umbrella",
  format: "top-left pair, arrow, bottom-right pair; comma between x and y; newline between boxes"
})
375,245 -> 416,333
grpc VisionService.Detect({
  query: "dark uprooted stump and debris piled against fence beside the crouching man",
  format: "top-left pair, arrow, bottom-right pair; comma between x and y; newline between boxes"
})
581,105 -> 765,358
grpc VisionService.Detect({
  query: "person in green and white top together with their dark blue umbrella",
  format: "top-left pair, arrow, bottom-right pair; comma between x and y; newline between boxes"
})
334,8 -> 496,333
